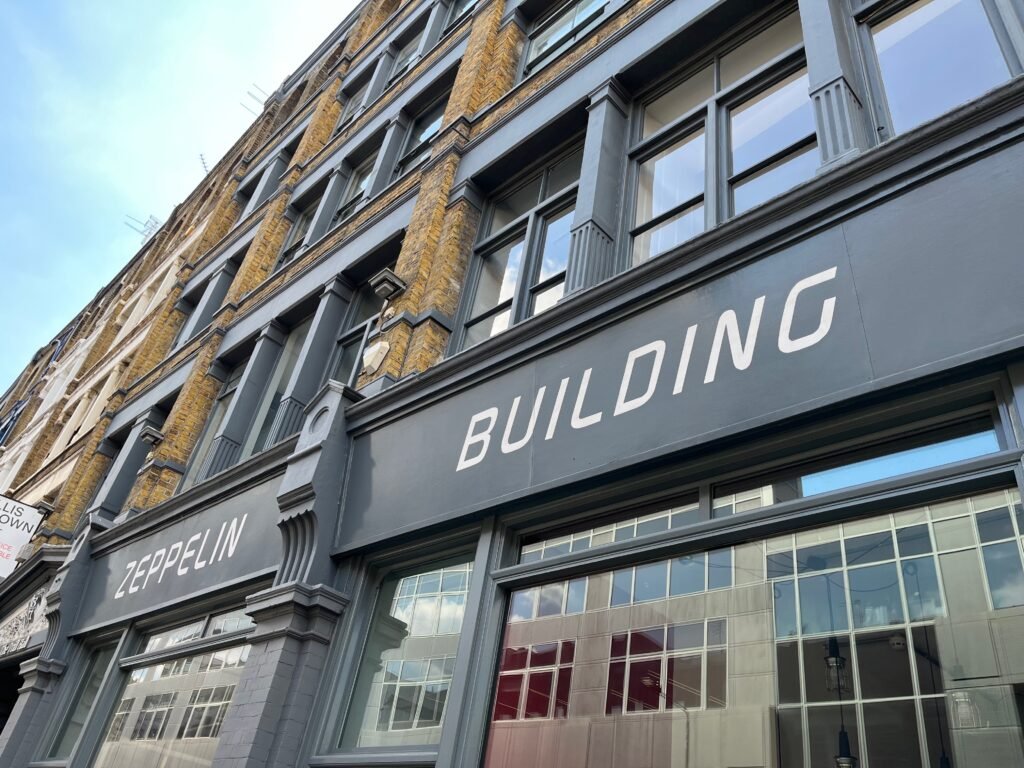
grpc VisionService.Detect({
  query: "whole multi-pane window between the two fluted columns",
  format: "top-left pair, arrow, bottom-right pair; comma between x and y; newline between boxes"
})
631,12 -> 818,264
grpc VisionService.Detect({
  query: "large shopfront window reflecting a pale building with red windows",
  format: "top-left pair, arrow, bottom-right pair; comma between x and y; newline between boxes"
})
485,488 -> 1024,768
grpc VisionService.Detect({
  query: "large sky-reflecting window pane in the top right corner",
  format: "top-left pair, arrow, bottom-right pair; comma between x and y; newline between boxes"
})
871,0 -> 1010,133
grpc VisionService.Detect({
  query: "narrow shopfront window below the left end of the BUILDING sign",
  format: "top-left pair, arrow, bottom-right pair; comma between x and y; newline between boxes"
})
339,559 -> 473,749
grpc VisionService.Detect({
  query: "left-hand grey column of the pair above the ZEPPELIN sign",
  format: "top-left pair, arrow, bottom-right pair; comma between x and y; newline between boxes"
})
200,321 -> 288,479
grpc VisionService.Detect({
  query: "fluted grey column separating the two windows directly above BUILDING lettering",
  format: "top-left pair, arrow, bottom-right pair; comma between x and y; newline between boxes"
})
565,79 -> 629,294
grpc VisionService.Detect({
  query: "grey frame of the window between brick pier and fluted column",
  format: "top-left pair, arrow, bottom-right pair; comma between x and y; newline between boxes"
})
449,139 -> 583,353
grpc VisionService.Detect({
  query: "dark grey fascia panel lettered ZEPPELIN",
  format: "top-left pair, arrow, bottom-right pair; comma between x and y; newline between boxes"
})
77,476 -> 282,628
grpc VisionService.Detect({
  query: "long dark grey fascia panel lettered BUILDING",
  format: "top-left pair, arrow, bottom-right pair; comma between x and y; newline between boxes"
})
338,144 -> 1024,550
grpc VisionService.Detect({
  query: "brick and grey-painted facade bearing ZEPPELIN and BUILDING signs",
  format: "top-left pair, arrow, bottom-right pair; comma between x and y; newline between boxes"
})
0,0 -> 1024,768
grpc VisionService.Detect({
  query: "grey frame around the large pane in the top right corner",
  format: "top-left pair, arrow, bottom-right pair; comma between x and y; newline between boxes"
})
849,0 -> 1024,143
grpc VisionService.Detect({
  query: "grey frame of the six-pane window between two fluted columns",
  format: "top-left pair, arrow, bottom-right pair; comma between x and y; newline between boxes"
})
622,4 -> 820,266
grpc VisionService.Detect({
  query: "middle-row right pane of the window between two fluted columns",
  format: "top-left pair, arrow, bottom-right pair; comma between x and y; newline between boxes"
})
729,71 -> 814,174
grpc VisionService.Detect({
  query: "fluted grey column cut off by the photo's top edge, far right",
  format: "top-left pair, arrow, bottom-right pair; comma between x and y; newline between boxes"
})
800,0 -> 871,167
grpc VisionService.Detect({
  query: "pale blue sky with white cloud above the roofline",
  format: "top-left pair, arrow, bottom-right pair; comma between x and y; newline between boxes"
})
0,0 -> 355,393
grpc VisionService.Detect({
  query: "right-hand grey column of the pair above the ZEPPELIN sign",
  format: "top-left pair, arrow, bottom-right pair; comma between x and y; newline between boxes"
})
270,276 -> 352,442
